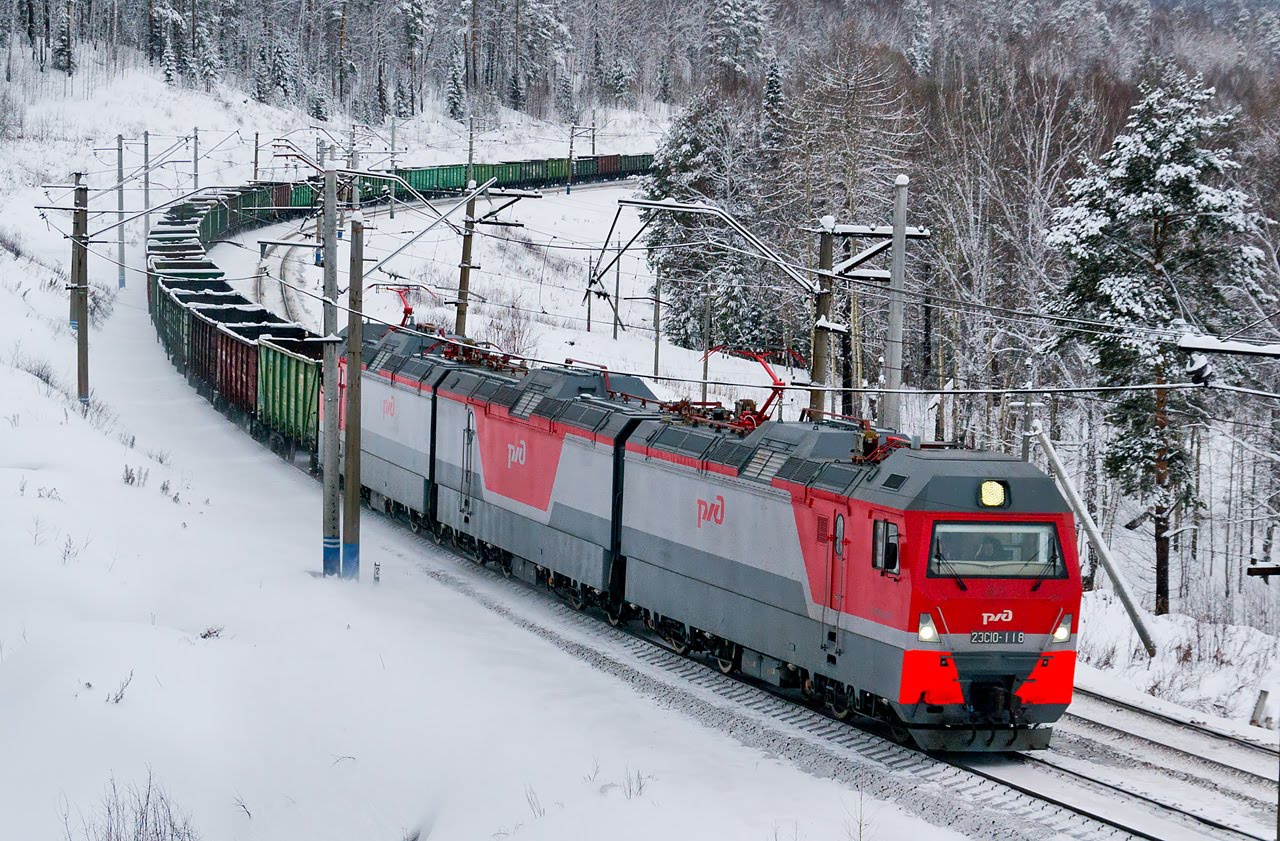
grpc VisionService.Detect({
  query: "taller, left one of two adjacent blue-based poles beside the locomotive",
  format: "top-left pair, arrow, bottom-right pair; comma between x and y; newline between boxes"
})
321,160 -> 340,575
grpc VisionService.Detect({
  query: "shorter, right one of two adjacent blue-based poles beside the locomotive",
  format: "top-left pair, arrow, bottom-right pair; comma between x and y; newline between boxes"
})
342,210 -> 365,580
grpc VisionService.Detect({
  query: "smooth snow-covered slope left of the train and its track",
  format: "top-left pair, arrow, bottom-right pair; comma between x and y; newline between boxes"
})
0,62 -> 948,840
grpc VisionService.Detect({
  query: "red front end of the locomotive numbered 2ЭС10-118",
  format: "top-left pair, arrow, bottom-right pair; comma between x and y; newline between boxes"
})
870,458 -> 1080,751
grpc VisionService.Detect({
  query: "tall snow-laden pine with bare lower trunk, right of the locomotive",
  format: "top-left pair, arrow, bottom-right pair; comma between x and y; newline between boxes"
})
1048,65 -> 1261,613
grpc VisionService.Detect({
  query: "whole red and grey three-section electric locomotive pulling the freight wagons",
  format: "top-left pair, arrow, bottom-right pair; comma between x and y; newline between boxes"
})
337,332 -> 1080,750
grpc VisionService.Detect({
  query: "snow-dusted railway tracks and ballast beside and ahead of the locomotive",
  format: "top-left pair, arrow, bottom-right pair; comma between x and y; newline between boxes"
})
145,165 -> 1277,840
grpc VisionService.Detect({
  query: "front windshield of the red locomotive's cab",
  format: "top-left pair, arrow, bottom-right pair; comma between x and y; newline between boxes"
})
929,522 -> 1066,579
